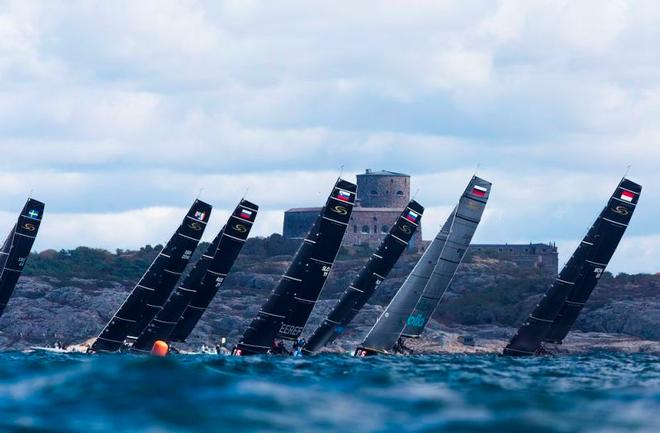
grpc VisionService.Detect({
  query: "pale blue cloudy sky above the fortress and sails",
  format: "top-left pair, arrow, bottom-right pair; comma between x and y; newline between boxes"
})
0,0 -> 660,272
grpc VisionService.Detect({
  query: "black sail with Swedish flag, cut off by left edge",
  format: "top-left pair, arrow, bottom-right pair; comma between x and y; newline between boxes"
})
0,198 -> 44,316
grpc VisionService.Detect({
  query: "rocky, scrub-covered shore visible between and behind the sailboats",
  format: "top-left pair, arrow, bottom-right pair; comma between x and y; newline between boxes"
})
0,251 -> 660,352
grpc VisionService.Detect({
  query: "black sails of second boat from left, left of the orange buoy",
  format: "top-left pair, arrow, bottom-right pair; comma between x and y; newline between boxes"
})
91,200 -> 211,352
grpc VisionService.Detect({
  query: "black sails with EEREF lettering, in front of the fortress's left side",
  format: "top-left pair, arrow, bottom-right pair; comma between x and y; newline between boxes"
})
234,179 -> 357,355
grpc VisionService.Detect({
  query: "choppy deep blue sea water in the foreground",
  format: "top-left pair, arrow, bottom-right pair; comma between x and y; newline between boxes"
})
0,352 -> 660,433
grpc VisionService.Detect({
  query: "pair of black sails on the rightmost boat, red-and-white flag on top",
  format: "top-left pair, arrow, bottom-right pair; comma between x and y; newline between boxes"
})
504,179 -> 642,356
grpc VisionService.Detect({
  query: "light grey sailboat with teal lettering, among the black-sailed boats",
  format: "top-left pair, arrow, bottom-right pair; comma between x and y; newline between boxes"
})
355,176 -> 491,356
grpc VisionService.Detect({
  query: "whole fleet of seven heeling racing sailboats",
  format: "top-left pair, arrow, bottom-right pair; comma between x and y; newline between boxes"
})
0,176 -> 642,356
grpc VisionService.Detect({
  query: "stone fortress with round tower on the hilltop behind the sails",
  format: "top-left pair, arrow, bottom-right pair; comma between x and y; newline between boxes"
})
283,169 -> 422,250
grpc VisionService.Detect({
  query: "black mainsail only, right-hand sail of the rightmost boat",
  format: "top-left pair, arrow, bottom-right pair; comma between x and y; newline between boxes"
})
544,179 -> 642,344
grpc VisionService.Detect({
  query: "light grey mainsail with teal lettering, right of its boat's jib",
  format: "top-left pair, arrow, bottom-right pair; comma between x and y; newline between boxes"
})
402,176 -> 491,338
